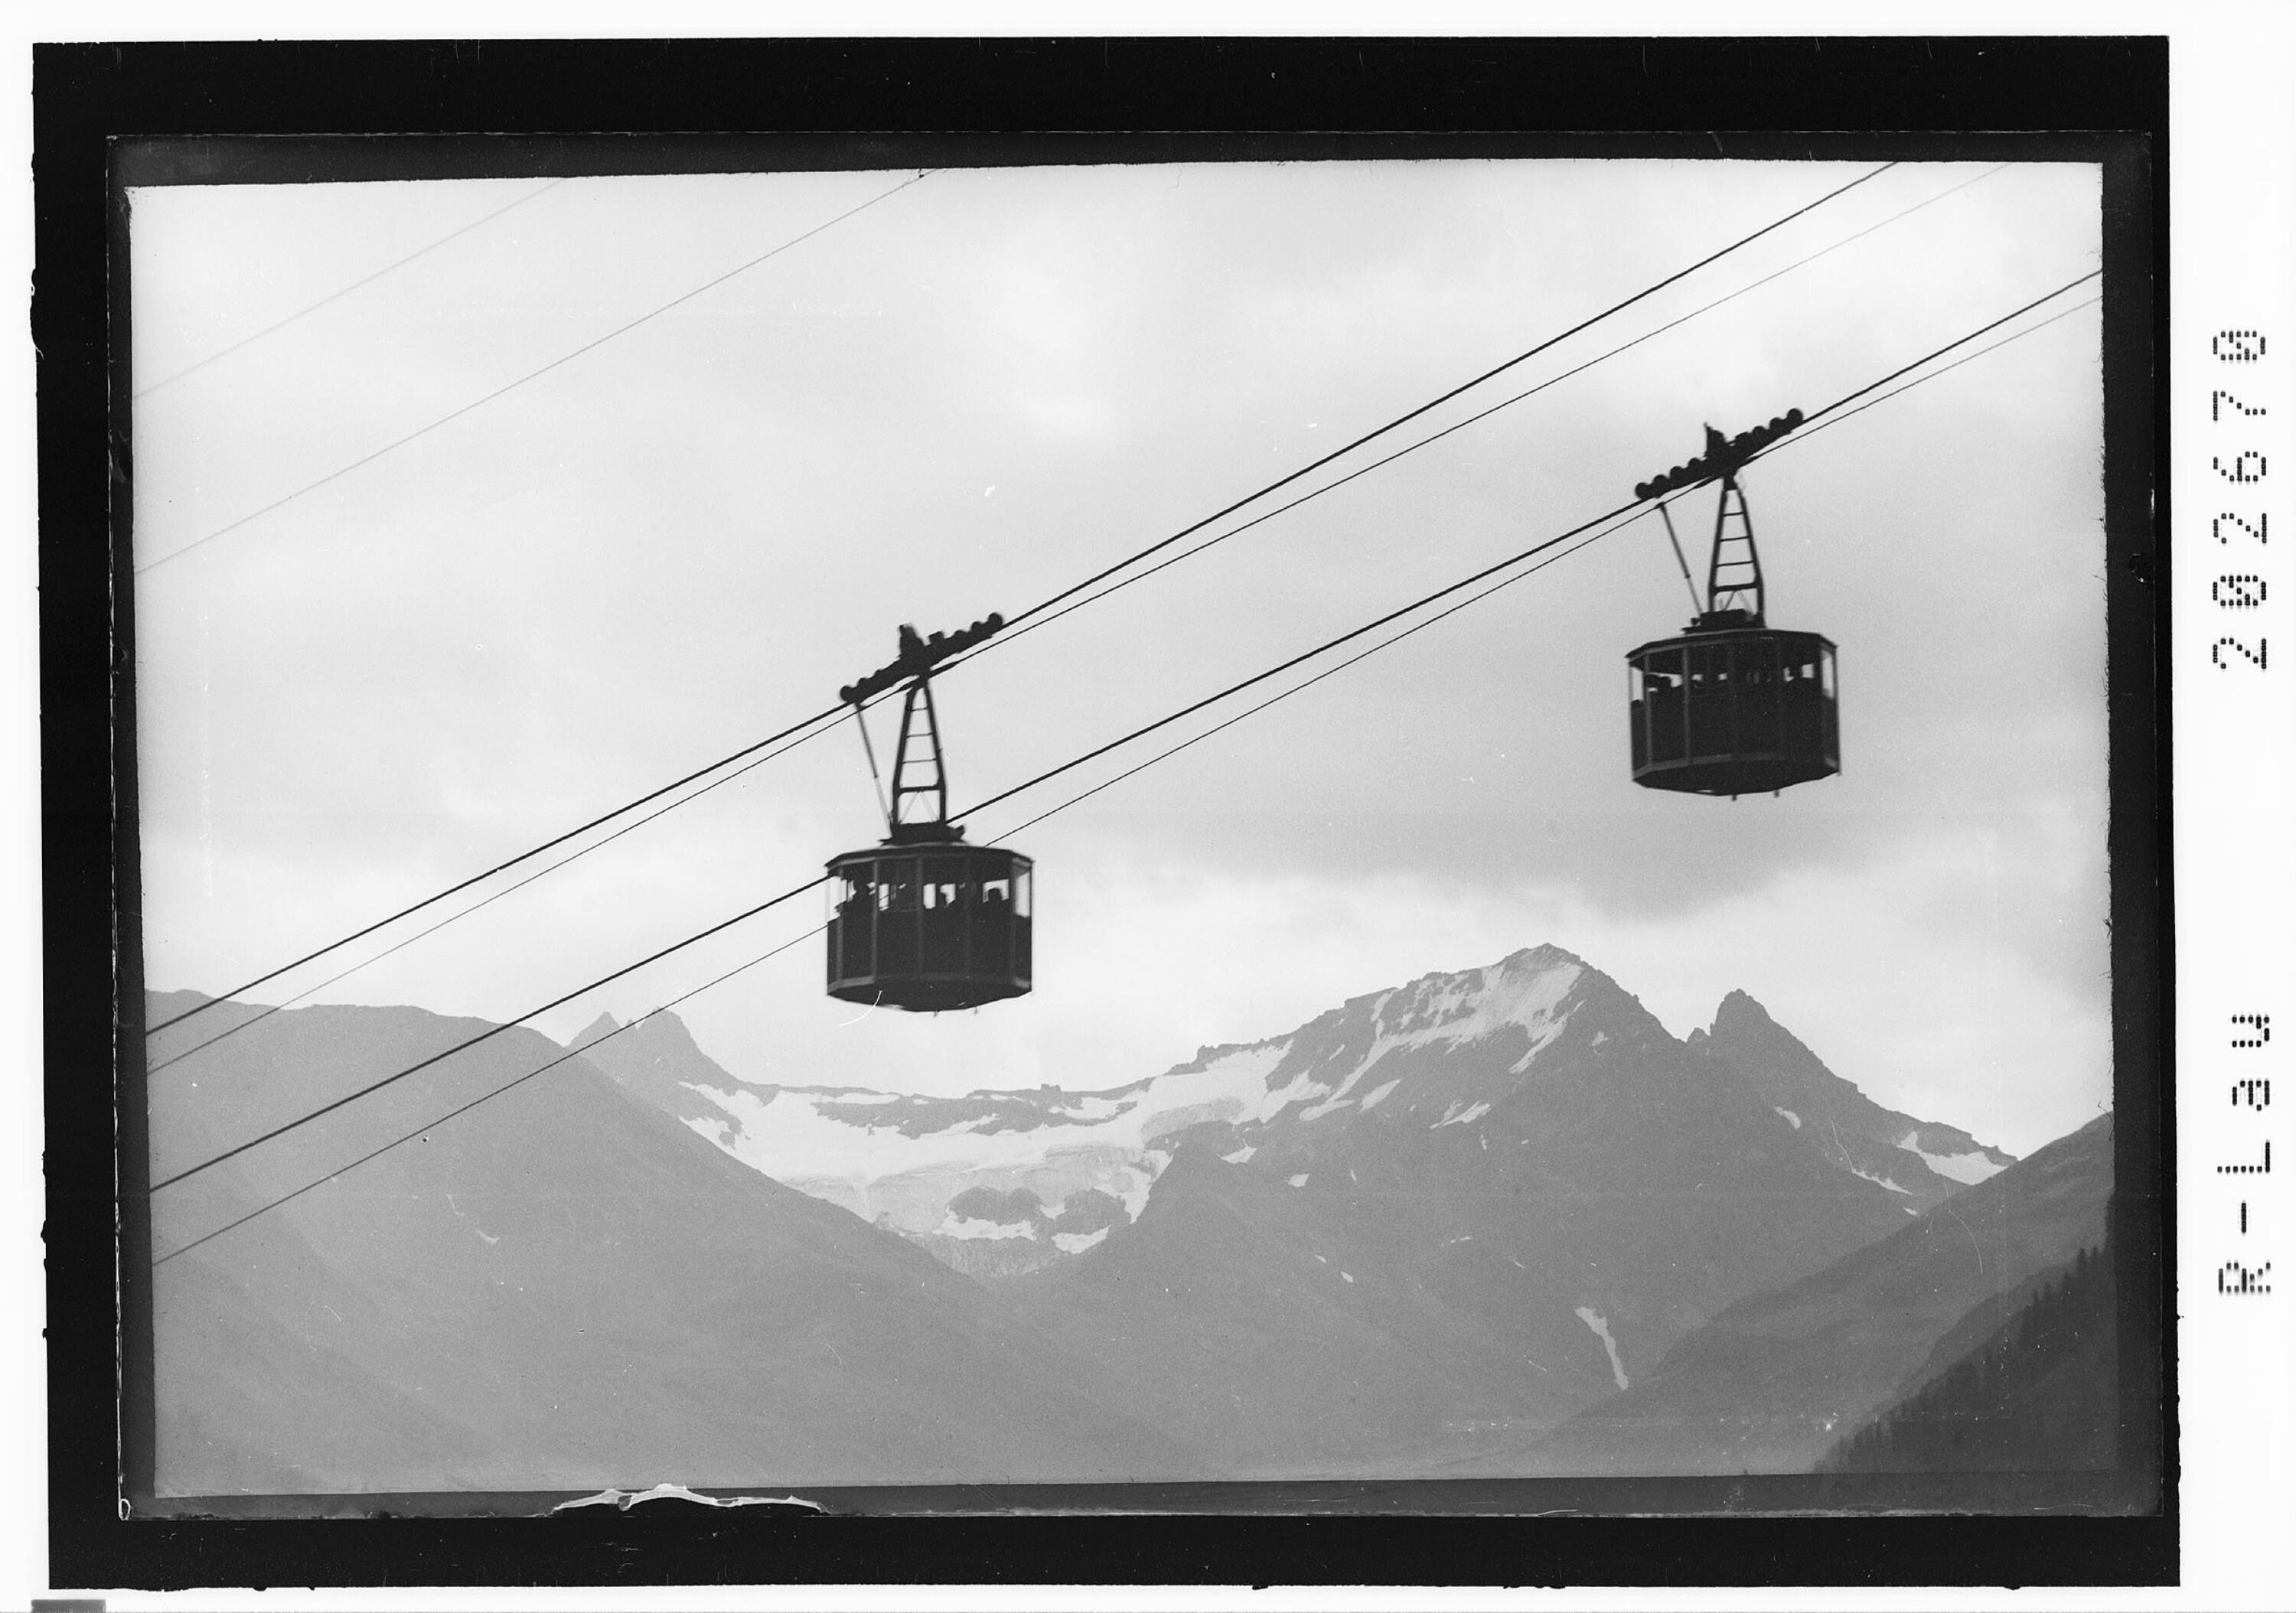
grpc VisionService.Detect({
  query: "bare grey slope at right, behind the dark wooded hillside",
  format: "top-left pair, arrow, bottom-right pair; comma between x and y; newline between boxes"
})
1520,1115 -> 2112,1473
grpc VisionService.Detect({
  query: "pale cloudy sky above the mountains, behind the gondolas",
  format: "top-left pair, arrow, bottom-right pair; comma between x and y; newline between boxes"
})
131,161 -> 2110,1152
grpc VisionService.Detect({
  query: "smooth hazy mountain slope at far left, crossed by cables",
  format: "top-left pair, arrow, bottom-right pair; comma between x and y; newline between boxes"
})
152,998 -> 1187,1494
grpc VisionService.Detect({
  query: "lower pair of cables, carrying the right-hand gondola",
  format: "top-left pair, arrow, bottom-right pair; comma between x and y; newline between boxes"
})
149,271 -> 2099,1264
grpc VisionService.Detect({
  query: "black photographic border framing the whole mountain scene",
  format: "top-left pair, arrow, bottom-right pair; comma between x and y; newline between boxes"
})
32,39 -> 2177,1588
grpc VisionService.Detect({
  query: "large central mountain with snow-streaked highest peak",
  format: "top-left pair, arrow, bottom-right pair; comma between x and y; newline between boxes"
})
1015,947 -> 1906,1475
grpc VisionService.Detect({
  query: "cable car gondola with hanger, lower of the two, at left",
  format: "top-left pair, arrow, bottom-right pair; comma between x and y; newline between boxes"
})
829,615 -> 1035,1014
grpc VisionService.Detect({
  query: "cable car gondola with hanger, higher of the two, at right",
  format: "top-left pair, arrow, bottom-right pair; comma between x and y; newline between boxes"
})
1626,409 -> 1841,799
